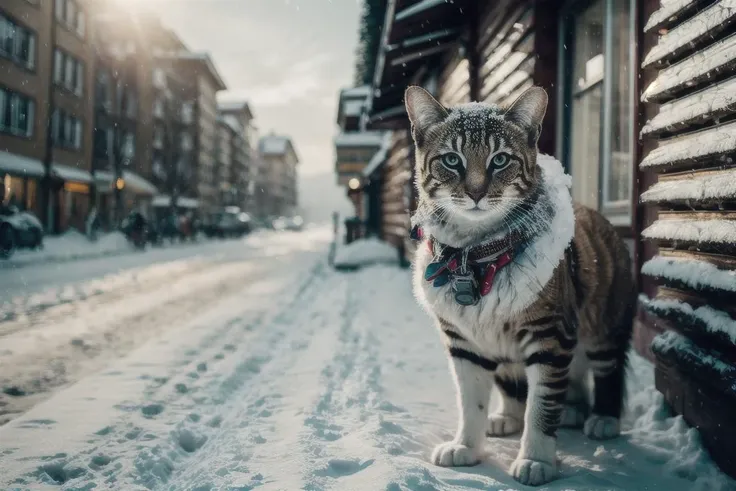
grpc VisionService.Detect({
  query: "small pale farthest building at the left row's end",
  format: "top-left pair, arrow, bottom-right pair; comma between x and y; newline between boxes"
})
258,132 -> 299,217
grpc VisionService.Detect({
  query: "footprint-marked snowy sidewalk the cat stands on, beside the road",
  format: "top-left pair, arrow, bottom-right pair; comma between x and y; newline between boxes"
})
0,236 -> 736,491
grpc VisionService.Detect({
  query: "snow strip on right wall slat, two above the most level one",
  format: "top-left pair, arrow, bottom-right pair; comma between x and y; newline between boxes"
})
640,123 -> 736,169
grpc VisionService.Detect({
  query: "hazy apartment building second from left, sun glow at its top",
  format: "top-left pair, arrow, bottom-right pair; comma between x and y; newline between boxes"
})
90,2 -> 158,229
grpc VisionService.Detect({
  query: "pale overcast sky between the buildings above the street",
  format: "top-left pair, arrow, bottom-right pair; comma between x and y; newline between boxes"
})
130,0 -> 360,175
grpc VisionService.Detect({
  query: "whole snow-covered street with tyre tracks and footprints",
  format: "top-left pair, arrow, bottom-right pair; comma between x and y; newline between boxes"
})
0,228 -> 736,491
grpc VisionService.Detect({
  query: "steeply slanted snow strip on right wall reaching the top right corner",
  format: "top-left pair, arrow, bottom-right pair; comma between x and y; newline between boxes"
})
642,0 -> 736,68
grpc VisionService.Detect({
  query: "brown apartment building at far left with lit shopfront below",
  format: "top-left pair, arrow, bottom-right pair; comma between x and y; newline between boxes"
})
0,0 -> 93,231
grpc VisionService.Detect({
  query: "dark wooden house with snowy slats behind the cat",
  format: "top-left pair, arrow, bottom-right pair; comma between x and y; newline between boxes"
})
366,0 -> 736,475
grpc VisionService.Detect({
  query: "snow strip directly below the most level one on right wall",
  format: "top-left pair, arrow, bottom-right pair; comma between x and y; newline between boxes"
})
641,256 -> 736,292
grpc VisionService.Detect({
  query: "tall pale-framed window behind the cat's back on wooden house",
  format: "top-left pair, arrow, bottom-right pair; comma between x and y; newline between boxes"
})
558,0 -> 635,225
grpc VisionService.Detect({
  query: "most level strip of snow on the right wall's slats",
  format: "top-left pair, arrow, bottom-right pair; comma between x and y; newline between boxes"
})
641,219 -> 736,244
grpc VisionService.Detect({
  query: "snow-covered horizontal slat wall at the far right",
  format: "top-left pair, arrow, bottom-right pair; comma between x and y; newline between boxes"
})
640,0 -> 736,475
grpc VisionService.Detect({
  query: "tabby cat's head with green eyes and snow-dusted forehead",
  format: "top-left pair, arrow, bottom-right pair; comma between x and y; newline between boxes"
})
405,87 -> 547,227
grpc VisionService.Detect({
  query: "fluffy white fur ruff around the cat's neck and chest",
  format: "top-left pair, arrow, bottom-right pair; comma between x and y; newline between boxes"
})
413,155 -> 575,358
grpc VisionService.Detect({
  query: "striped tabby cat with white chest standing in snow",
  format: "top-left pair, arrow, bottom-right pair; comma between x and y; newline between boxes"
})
405,87 -> 635,485
